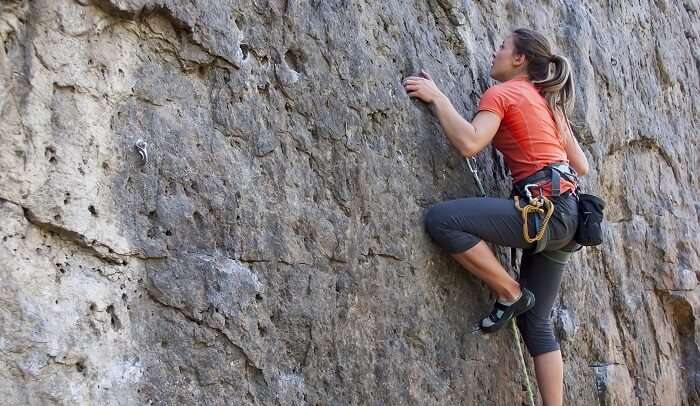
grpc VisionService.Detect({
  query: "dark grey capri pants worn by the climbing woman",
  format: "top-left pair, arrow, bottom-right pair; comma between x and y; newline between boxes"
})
425,192 -> 579,357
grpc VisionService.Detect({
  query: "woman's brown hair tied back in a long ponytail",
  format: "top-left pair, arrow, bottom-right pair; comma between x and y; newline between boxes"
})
513,28 -> 575,141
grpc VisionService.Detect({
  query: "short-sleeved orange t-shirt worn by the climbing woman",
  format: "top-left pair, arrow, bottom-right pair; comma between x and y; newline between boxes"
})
479,79 -> 574,195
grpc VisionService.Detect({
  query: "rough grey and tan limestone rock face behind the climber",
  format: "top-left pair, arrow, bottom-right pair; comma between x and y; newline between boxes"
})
0,0 -> 700,405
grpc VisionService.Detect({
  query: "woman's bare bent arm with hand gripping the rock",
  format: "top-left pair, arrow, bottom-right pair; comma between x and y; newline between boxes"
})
404,71 -> 501,158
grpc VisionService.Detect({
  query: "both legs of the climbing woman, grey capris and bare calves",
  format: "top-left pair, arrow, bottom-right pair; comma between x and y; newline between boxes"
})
425,198 -> 576,406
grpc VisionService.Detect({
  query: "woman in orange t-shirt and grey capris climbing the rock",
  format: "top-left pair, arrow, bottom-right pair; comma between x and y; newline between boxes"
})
403,29 -> 588,406
